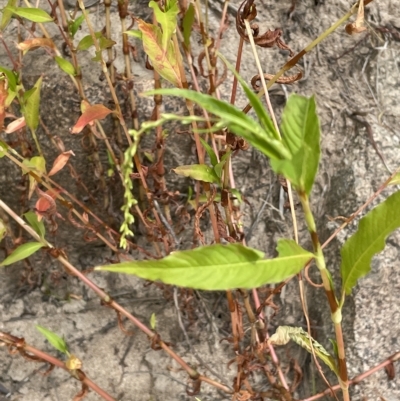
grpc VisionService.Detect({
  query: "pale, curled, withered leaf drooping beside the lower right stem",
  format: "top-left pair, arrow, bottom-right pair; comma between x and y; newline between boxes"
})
268,326 -> 338,374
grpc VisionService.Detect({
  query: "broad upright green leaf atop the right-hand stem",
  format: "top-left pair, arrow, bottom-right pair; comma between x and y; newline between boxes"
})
271,95 -> 321,195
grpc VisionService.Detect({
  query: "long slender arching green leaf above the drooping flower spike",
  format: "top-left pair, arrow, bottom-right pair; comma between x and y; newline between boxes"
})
144,89 -> 291,159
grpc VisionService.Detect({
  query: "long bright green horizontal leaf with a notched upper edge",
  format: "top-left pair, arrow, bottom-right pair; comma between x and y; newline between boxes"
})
96,240 -> 313,290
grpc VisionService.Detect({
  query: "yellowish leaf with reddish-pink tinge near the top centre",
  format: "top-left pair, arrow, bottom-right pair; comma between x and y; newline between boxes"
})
138,20 -> 182,88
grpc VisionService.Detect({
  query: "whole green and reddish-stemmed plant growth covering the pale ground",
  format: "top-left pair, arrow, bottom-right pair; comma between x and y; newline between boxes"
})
0,0 -> 400,401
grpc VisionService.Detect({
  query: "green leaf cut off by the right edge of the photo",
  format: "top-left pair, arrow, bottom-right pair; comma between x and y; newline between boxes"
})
340,192 -> 400,294
